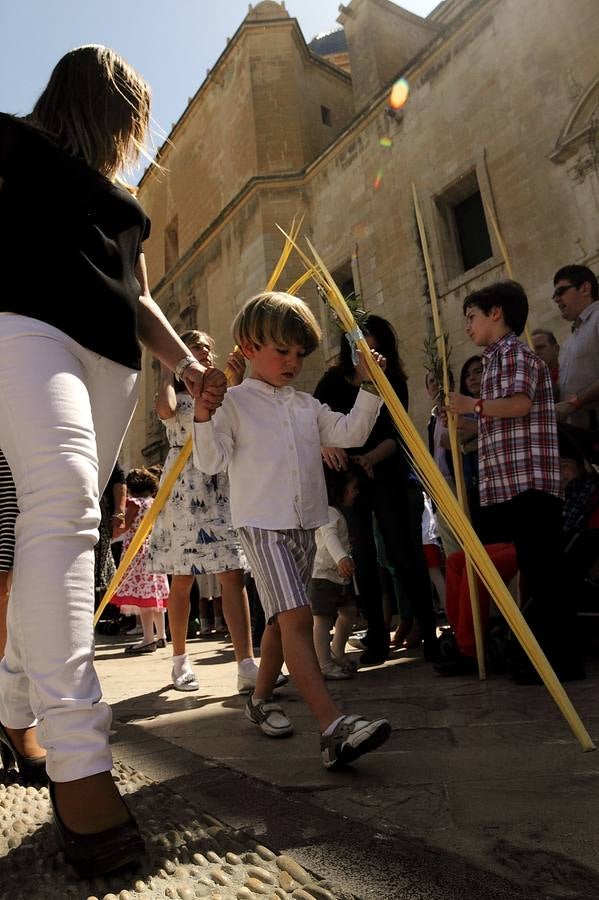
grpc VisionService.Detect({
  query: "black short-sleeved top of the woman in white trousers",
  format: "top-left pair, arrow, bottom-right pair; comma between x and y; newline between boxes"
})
0,113 -> 150,369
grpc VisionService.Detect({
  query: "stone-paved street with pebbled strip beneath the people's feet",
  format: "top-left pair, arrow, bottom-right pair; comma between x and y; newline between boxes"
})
0,635 -> 599,900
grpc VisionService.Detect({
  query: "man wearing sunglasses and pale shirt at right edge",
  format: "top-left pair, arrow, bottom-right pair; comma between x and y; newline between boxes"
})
553,265 -> 599,431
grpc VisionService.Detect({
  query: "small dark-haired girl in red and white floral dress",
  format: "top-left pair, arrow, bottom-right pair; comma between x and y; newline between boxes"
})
110,469 -> 169,654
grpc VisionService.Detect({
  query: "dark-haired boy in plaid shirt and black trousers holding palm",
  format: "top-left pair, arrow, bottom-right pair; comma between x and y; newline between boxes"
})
449,281 -> 584,683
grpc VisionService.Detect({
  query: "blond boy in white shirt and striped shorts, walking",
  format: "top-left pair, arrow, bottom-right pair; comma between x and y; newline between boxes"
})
193,293 -> 391,768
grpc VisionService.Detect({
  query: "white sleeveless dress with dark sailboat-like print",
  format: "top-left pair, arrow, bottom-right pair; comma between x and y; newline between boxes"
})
148,393 -> 247,575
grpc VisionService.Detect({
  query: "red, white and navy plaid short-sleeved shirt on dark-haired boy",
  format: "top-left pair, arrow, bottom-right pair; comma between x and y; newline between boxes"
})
478,331 -> 562,506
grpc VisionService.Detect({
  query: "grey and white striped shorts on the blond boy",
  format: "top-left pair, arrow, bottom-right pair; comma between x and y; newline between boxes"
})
238,525 -> 316,623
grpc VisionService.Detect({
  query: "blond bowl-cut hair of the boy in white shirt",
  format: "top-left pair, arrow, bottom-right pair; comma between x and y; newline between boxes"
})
233,291 -> 322,356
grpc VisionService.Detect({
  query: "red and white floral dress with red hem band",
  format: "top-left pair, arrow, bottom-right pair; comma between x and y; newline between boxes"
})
110,497 -> 169,614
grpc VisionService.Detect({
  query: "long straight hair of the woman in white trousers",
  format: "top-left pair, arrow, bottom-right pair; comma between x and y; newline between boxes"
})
28,44 -> 151,180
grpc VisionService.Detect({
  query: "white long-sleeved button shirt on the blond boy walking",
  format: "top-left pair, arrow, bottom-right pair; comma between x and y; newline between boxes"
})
193,378 -> 382,530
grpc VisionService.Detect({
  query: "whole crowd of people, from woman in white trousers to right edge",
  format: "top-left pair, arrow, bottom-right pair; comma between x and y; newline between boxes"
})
0,46 -> 599,876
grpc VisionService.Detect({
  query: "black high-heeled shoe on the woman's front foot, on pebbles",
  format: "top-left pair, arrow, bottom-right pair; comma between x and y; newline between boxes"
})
48,781 -> 146,878
